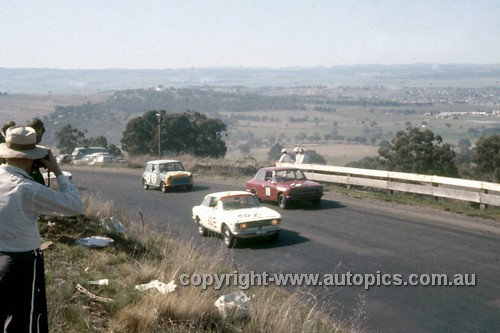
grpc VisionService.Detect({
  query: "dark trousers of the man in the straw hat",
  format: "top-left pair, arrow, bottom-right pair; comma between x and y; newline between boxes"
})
0,250 -> 48,333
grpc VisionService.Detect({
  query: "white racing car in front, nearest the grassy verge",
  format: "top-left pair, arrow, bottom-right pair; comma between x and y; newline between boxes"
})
192,191 -> 281,247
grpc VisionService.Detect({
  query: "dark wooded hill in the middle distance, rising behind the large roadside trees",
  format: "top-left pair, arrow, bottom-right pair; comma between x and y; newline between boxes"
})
43,88 -> 305,143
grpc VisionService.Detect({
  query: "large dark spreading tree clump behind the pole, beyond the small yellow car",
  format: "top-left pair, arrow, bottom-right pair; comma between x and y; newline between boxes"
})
121,110 -> 227,157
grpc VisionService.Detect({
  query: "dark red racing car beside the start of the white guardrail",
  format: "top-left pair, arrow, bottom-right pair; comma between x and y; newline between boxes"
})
246,167 -> 323,208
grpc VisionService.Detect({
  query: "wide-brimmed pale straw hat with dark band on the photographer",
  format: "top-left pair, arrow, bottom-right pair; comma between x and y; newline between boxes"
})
0,126 -> 48,160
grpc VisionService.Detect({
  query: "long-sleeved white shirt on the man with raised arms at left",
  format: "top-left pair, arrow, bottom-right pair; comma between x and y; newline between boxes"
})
0,164 -> 83,252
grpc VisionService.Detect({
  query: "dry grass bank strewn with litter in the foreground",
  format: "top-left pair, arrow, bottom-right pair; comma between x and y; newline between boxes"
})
40,196 -> 357,333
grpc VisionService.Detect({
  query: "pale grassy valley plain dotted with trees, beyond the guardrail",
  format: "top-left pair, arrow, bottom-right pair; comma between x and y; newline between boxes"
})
223,104 -> 500,165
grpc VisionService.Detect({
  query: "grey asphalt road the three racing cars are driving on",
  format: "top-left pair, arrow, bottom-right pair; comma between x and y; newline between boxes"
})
71,169 -> 500,332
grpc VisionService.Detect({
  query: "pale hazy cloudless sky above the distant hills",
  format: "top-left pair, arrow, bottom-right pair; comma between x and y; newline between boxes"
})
0,0 -> 500,69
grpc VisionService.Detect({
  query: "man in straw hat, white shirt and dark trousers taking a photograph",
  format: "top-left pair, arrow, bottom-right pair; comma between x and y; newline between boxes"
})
0,127 -> 83,332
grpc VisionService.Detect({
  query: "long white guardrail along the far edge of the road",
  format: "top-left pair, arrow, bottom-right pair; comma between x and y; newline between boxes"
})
276,163 -> 500,208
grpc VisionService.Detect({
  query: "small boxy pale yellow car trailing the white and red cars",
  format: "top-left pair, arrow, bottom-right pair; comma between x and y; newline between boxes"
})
142,160 -> 193,192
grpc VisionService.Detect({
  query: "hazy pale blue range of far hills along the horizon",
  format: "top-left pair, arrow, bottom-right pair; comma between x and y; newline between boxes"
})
0,64 -> 500,94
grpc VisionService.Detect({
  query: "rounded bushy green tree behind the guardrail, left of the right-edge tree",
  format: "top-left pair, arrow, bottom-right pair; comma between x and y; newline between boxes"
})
379,127 -> 458,177
